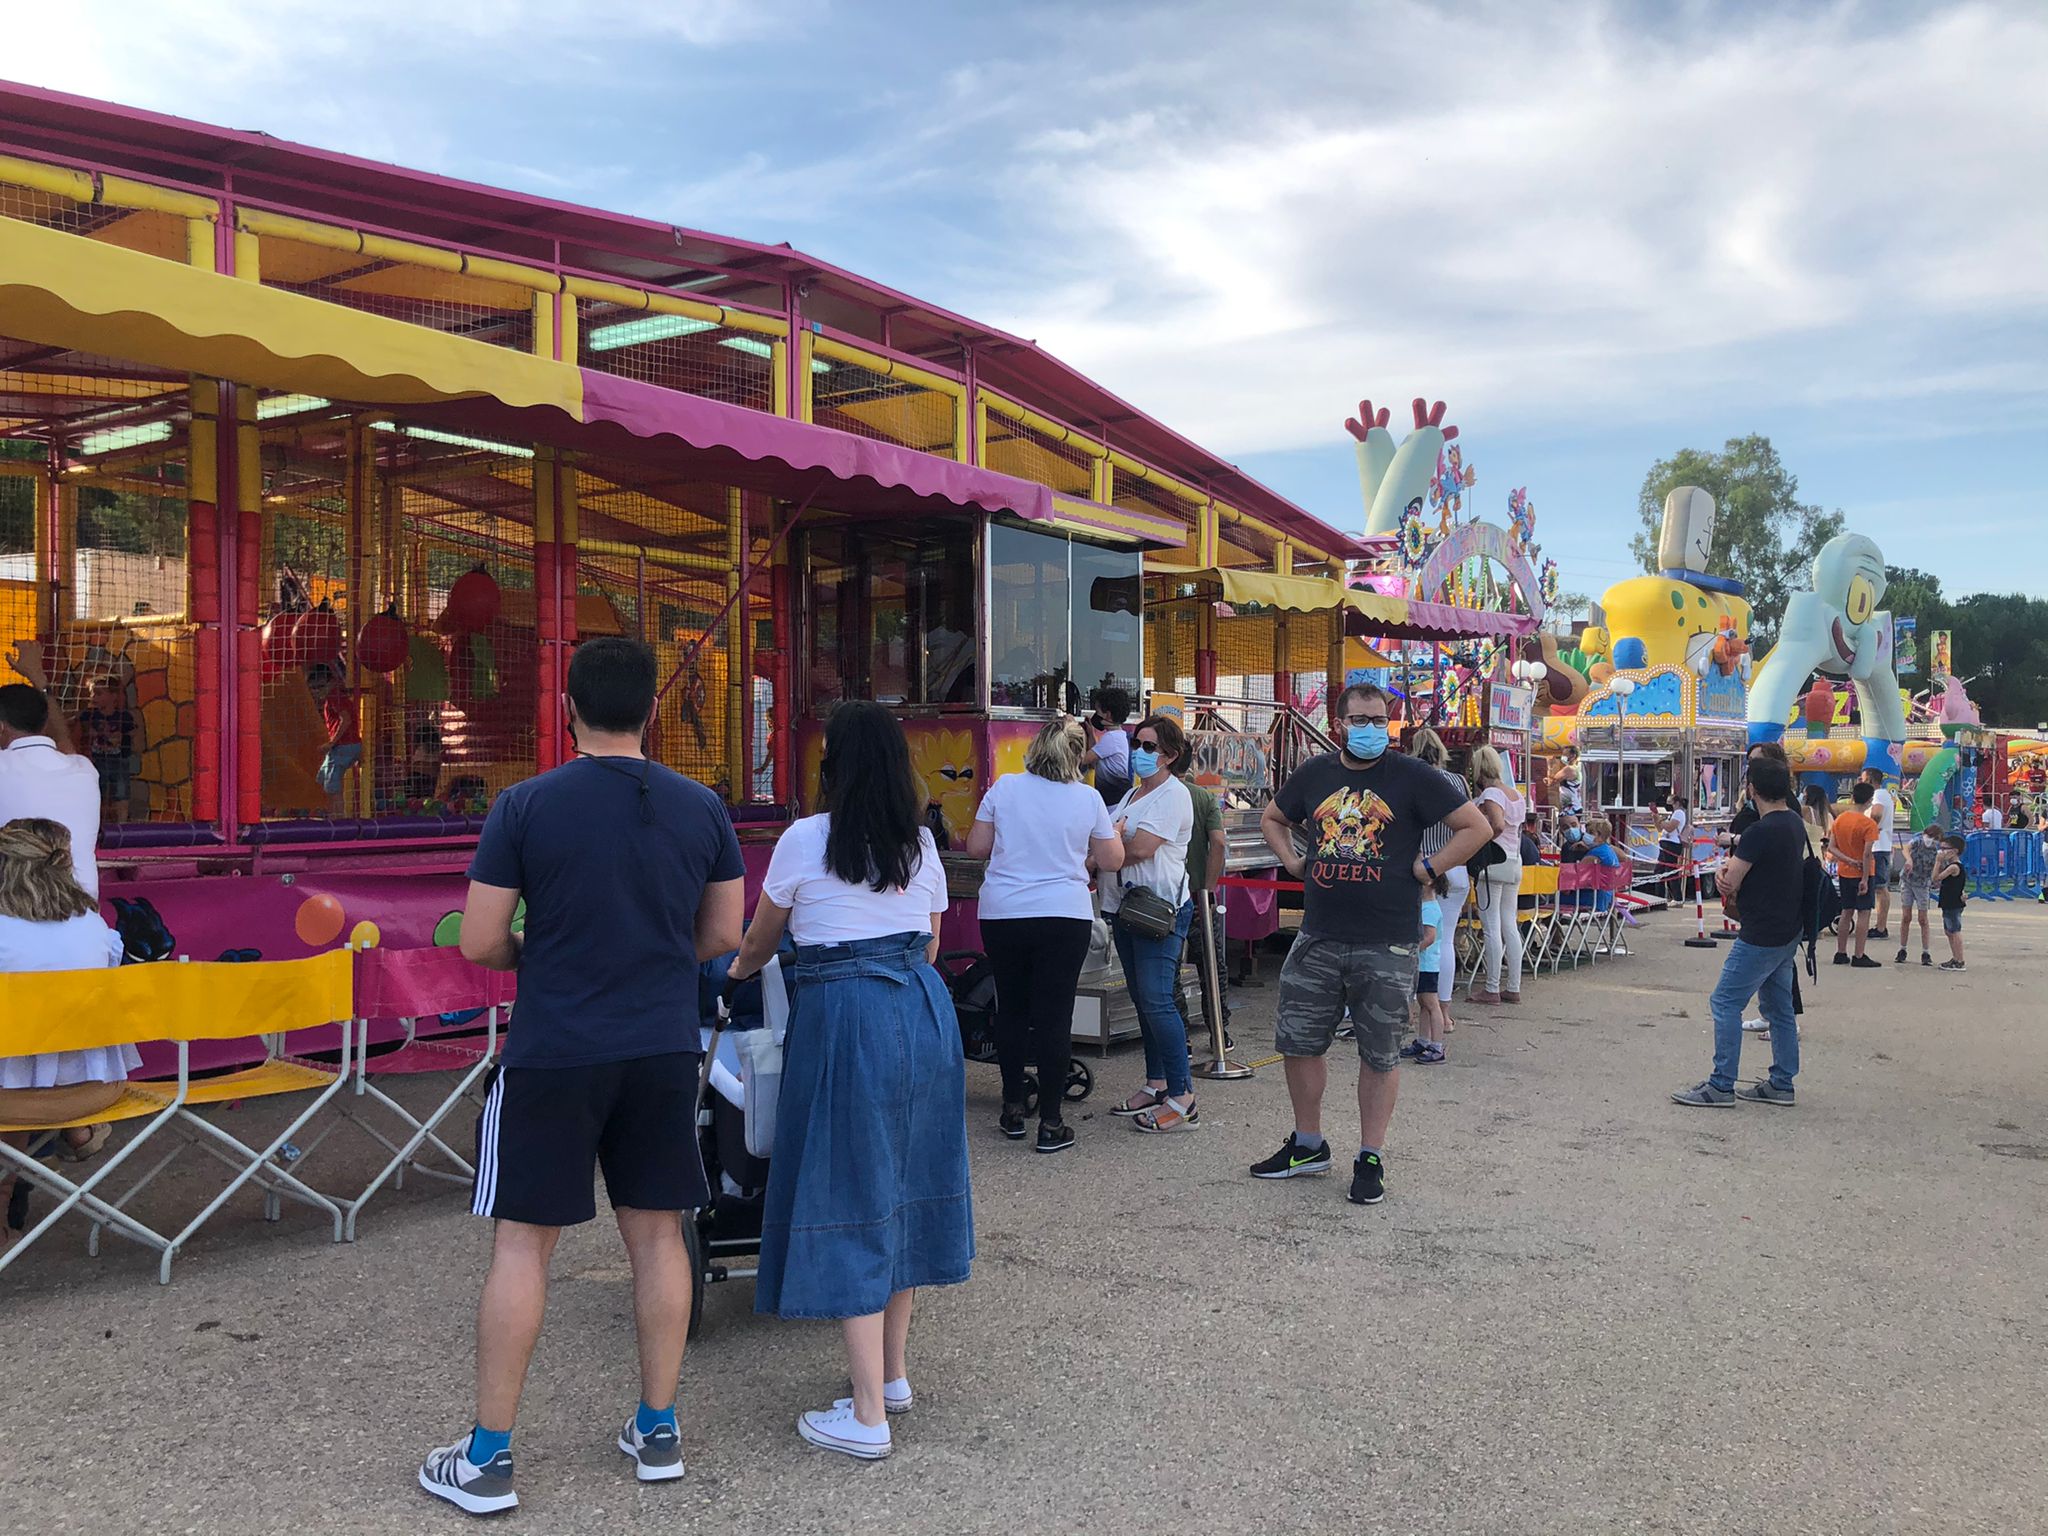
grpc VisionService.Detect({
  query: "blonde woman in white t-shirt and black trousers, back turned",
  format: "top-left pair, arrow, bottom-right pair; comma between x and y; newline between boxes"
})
967,715 -> 1124,1153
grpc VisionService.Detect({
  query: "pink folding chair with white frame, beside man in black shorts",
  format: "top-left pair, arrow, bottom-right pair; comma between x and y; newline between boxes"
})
331,946 -> 518,1243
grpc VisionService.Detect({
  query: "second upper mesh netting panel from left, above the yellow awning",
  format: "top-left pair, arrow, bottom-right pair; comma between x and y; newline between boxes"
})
256,236 -> 532,352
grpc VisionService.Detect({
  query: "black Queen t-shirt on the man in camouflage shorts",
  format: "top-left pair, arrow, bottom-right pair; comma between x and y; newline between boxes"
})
1274,752 -> 1470,944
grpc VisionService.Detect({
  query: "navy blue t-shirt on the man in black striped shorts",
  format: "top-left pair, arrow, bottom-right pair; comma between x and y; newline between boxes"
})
469,758 -> 743,1067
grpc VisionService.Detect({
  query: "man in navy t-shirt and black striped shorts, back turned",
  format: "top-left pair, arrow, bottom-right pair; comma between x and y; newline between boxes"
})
420,639 -> 745,1513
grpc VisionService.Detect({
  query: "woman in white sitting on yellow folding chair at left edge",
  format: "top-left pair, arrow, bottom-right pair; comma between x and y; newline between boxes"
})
0,817 -> 141,1243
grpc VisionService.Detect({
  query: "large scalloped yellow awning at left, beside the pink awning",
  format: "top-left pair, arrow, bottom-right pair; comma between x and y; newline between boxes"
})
0,219 -> 584,420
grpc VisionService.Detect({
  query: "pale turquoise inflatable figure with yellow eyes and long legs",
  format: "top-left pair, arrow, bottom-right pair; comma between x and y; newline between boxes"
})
1749,532 -> 1907,774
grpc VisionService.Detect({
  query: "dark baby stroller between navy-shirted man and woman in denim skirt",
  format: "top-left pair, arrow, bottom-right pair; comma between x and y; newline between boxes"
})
682,954 -> 791,1339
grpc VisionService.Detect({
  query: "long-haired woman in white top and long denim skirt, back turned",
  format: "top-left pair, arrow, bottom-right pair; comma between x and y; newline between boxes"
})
731,702 -> 975,1460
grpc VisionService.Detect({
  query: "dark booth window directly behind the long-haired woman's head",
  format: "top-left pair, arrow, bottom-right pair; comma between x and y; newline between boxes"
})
805,518 -> 977,715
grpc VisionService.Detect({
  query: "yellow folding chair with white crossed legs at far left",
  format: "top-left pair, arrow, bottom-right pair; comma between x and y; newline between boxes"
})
0,950 -> 352,1284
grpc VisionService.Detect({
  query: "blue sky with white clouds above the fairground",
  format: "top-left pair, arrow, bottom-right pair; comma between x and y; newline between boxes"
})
0,0 -> 2048,598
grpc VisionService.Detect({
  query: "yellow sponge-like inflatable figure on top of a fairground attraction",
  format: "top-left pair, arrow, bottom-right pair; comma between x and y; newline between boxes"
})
1599,485 -> 1749,672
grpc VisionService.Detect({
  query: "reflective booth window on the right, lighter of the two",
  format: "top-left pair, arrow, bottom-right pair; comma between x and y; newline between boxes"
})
989,522 -> 1145,713
